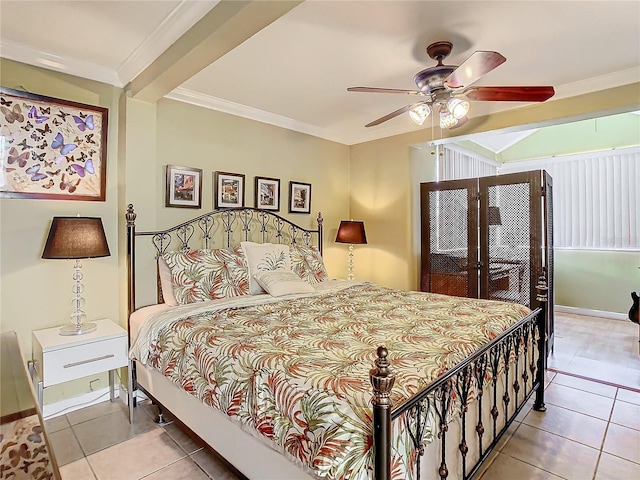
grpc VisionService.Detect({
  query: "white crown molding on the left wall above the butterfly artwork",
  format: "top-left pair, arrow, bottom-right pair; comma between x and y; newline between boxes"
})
0,40 -> 124,87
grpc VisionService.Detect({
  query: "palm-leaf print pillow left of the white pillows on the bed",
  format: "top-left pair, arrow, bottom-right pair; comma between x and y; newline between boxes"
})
163,247 -> 249,305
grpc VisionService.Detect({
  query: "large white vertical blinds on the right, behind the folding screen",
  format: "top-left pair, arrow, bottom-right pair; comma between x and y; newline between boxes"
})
499,147 -> 640,250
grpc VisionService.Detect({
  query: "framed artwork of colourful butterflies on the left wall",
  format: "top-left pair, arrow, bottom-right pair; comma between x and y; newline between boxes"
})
0,87 -> 109,202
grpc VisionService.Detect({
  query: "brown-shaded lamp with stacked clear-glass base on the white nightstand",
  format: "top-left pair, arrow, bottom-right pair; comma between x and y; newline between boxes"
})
42,216 -> 111,335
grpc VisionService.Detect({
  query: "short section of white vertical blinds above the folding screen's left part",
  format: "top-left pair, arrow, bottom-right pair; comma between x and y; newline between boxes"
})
438,146 -> 499,181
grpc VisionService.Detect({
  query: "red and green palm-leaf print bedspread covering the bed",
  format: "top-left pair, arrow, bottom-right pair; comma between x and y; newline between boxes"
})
131,282 -> 530,479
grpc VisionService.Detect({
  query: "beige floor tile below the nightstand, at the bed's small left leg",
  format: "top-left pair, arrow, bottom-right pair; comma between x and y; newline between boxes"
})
73,404 -> 160,455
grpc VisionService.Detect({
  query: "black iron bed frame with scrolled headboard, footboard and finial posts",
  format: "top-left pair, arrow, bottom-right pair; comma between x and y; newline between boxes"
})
126,204 -> 548,480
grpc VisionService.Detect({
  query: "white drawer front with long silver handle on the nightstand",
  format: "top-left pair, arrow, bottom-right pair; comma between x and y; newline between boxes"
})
40,337 -> 127,387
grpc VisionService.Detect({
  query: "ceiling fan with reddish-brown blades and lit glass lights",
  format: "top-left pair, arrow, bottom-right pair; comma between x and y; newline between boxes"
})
347,41 -> 555,129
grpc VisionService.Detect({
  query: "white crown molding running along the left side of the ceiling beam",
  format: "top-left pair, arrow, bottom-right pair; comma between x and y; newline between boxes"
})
118,0 -> 220,85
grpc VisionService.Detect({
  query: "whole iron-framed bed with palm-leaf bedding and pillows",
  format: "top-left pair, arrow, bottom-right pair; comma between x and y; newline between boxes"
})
126,205 -> 546,480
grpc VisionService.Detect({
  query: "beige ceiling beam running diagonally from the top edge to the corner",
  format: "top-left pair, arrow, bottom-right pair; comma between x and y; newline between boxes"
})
126,0 -> 302,102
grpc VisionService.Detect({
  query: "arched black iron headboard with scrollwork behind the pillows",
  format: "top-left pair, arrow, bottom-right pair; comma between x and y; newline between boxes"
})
126,204 -> 323,315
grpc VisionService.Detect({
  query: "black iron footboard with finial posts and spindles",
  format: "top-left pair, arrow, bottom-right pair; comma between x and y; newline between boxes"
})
369,277 -> 547,480
